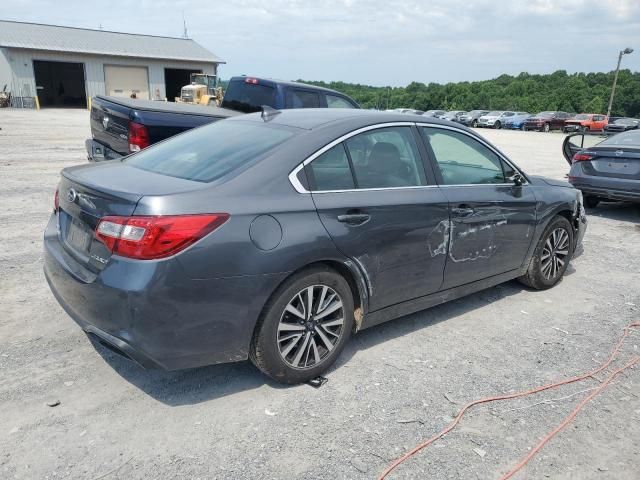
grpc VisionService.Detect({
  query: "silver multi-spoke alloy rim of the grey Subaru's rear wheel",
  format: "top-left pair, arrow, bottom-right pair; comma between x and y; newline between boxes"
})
277,285 -> 344,370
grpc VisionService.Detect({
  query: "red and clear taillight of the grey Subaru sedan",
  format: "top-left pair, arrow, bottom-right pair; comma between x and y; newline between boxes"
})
96,213 -> 229,260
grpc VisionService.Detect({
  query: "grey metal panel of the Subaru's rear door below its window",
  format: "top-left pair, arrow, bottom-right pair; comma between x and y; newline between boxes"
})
312,187 -> 449,311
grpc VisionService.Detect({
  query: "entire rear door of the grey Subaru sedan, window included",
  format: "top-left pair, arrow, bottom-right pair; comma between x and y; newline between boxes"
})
305,123 -> 449,311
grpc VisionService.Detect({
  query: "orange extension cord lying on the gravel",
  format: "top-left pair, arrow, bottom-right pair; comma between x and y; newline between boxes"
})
378,323 -> 640,480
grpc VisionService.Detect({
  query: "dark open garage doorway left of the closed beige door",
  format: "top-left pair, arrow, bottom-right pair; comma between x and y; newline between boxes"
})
33,60 -> 87,108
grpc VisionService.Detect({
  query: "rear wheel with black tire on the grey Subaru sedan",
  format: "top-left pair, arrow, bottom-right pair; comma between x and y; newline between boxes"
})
249,267 -> 354,384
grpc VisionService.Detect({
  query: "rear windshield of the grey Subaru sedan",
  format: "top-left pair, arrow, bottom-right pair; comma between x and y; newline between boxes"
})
125,121 -> 294,182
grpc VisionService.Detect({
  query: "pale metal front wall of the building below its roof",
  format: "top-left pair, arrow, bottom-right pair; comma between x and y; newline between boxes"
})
0,48 -> 216,104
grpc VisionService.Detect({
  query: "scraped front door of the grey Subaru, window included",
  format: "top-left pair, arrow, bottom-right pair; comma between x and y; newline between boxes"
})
421,127 -> 536,289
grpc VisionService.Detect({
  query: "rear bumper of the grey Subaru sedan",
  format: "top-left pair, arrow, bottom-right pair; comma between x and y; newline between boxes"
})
44,215 -> 286,370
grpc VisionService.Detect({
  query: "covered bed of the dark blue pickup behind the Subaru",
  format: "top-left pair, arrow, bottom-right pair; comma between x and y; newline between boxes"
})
86,95 -> 242,161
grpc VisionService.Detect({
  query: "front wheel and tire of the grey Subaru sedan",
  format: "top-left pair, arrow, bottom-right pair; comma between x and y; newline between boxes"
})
518,215 -> 573,290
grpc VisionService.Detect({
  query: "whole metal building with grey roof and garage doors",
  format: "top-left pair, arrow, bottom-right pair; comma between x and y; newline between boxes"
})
0,20 -> 225,107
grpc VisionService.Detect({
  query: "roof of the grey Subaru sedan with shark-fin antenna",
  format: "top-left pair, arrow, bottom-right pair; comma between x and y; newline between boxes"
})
230,108 -> 465,130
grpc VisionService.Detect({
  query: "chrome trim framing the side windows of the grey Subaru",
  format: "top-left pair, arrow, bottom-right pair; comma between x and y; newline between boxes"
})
289,122 -> 529,194
